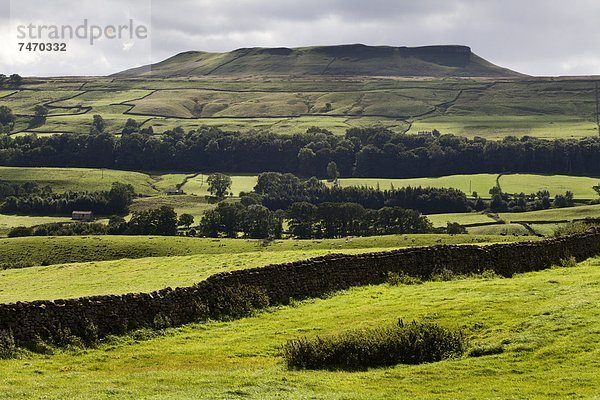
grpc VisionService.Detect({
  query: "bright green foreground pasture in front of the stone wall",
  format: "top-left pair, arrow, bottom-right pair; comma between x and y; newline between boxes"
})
0,258 -> 600,399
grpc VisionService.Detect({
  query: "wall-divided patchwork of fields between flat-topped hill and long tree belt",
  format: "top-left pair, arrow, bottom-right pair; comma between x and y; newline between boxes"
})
0,76 -> 598,139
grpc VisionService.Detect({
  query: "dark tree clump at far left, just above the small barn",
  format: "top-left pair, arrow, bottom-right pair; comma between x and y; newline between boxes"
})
0,182 -> 135,215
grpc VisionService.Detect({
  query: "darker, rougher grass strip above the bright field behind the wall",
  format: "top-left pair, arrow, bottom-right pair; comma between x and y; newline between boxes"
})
0,234 -> 528,274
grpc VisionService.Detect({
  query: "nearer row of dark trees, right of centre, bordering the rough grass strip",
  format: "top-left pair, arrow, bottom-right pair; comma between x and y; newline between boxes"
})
287,202 -> 433,239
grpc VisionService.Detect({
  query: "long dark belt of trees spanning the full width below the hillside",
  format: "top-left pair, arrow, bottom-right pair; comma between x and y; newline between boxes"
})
0,125 -> 600,178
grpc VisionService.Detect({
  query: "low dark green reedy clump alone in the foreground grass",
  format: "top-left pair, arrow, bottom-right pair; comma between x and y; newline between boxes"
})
282,320 -> 465,370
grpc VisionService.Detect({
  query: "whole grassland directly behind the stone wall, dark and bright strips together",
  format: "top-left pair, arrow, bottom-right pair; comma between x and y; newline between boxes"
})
0,235 -> 536,302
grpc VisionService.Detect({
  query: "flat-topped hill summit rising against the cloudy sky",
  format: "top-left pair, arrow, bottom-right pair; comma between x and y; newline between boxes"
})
114,44 -> 522,78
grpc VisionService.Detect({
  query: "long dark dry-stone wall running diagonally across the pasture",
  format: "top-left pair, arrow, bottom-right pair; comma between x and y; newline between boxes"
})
0,230 -> 600,344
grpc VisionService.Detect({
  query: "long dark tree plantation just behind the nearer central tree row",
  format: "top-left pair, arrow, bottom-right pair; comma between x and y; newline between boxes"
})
251,172 -> 471,214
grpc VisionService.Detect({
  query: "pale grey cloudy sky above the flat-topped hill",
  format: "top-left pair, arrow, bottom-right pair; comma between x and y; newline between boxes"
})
0,0 -> 600,76
